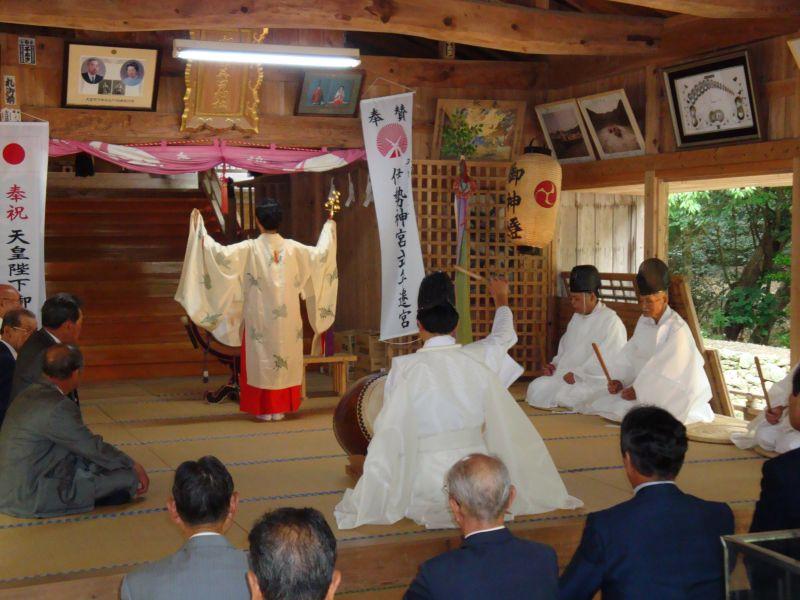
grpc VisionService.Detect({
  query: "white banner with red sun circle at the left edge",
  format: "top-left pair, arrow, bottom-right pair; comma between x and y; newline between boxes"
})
0,123 -> 50,319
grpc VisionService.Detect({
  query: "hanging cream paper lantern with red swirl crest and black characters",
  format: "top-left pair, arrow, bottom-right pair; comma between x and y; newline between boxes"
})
506,146 -> 561,248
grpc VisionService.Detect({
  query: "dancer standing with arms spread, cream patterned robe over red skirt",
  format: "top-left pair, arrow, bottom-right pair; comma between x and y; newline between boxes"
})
175,199 -> 339,421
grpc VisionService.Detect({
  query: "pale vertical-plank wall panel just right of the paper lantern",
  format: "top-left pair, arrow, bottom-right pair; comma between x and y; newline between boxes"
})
554,192 -> 644,284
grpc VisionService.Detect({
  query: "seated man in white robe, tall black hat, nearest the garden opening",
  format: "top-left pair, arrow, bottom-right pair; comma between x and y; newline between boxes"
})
579,258 -> 714,425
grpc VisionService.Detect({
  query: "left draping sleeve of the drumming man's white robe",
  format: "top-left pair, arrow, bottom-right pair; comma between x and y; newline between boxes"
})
334,369 -> 418,529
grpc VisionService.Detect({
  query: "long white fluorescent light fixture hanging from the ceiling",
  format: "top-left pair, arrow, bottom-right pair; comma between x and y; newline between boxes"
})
177,40 -> 361,69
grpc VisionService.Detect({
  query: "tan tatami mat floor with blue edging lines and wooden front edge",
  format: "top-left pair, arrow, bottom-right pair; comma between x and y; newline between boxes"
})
0,374 -> 763,599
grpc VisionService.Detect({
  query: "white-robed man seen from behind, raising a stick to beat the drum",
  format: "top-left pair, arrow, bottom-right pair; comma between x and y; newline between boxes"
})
335,273 -> 582,529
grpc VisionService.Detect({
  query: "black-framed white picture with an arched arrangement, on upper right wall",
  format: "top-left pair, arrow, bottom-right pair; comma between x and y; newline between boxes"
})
664,52 -> 761,148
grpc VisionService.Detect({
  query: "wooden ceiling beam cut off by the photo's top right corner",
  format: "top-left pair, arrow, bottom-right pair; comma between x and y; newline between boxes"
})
613,0 -> 800,19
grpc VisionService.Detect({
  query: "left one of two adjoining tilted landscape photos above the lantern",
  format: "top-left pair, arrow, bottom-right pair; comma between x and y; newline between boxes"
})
536,98 -> 596,163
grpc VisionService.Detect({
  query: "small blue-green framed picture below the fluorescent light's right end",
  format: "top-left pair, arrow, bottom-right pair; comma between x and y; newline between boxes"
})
295,70 -> 364,117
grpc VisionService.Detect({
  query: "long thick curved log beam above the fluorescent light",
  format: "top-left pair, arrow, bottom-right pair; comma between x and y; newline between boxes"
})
0,0 -> 663,55
